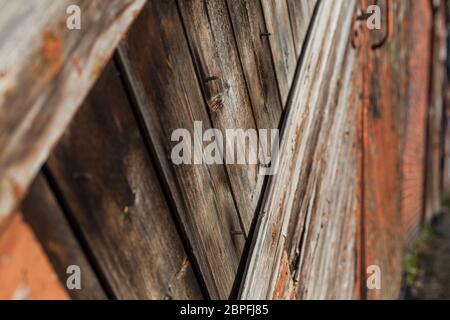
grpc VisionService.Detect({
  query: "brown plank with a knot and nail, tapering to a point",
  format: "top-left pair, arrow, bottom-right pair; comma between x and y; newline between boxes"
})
178,0 -> 265,232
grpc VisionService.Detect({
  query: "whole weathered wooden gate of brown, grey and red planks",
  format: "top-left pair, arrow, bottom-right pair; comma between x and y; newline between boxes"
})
0,0 -> 446,299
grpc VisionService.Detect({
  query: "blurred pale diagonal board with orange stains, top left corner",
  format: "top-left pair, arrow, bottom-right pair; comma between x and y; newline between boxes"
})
0,0 -> 145,225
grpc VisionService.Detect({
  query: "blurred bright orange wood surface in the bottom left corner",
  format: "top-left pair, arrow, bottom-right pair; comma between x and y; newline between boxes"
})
0,213 -> 69,300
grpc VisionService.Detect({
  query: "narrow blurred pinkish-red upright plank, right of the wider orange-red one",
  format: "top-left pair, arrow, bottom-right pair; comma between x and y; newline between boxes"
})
402,1 -> 432,245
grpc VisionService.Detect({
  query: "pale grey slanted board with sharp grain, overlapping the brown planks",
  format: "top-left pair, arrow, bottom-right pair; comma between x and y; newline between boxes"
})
240,0 -> 355,299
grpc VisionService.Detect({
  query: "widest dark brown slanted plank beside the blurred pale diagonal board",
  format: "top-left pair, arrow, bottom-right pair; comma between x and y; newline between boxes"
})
48,63 -> 202,299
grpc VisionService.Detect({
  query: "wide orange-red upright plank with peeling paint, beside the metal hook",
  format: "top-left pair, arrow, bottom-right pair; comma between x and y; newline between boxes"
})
362,1 -> 411,299
